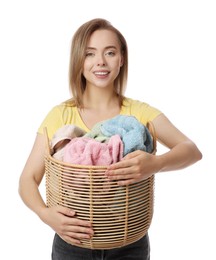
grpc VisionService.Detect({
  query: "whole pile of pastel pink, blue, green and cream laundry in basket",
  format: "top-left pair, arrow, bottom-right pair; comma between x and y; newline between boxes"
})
51,115 -> 153,166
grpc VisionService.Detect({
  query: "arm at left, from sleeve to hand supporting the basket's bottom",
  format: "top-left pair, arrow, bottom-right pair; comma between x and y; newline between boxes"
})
19,134 -> 93,244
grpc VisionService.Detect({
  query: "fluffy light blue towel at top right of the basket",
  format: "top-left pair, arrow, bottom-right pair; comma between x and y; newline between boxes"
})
101,115 -> 153,156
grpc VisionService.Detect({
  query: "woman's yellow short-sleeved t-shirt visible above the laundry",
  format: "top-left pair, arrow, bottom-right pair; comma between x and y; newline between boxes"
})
38,98 -> 161,139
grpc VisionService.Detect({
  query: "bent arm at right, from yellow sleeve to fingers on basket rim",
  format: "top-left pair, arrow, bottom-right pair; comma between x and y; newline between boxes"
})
106,114 -> 202,185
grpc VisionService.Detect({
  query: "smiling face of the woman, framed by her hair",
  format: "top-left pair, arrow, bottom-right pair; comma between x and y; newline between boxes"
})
83,30 -> 123,88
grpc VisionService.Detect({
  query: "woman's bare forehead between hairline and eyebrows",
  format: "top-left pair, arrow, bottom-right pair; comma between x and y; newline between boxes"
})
87,30 -> 120,48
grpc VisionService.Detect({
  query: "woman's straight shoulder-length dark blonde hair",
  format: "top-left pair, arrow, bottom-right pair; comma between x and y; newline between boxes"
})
66,18 -> 128,107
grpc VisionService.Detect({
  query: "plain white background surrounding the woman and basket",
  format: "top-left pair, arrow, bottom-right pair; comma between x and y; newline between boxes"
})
0,0 -> 216,260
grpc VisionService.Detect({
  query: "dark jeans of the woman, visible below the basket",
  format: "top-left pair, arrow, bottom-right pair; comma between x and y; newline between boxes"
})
52,234 -> 150,260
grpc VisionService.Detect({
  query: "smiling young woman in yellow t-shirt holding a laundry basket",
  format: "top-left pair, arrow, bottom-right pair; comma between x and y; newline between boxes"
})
19,19 -> 202,260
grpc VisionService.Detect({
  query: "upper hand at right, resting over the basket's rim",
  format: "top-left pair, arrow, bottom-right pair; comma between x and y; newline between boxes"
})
105,150 -> 159,186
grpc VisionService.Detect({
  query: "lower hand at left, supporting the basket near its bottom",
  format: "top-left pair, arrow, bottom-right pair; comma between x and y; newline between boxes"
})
40,206 -> 94,245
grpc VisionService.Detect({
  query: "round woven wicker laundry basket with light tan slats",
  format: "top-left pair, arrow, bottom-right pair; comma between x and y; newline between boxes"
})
45,123 -> 156,249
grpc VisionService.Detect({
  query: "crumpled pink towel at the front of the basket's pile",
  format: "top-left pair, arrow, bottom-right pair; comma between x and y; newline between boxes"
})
63,135 -> 123,166
